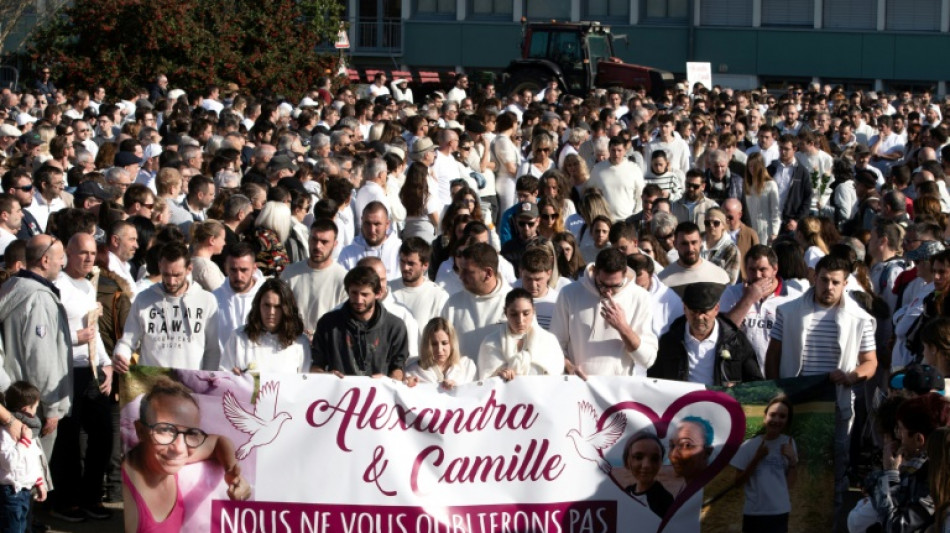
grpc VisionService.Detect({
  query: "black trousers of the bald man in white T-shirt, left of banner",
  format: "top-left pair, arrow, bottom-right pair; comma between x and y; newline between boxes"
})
50,367 -> 114,509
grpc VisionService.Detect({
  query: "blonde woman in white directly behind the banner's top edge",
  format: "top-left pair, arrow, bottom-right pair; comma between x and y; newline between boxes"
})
404,316 -> 476,390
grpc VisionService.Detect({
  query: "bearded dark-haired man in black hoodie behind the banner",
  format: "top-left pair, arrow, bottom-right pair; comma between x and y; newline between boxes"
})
311,266 -> 409,381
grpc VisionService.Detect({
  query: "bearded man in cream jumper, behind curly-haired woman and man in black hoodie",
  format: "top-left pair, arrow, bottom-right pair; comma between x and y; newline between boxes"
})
281,218 -> 346,333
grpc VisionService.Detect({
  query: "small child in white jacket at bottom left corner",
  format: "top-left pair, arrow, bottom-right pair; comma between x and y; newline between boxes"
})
0,381 -> 49,533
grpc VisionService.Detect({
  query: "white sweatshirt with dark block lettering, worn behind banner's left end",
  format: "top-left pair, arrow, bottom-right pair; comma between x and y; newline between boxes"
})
115,283 -> 221,370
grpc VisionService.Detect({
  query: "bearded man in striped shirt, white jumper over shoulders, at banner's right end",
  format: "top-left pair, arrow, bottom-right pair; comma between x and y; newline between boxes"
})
765,255 -> 877,504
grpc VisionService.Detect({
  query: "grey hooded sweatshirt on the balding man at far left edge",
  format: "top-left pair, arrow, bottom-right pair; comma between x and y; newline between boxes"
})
0,270 -> 73,418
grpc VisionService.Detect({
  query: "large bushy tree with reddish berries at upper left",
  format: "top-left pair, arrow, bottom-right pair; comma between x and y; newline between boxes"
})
30,0 -> 350,96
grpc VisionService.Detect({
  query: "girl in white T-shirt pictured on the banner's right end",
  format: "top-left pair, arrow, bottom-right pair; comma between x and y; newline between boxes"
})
729,395 -> 798,533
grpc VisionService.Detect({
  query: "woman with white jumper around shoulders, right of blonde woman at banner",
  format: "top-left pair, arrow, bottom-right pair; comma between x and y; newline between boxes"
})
478,288 -> 564,381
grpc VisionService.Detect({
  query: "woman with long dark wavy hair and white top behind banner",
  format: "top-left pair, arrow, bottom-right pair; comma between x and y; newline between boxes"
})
221,278 -> 310,375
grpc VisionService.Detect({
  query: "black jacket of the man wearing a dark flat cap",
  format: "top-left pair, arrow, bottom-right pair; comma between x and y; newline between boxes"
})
647,315 -> 762,386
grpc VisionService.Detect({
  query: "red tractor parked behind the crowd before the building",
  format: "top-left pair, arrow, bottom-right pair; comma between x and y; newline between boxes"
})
502,22 -> 673,99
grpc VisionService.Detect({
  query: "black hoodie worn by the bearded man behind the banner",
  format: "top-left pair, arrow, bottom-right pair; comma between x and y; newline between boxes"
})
311,302 -> 409,376
